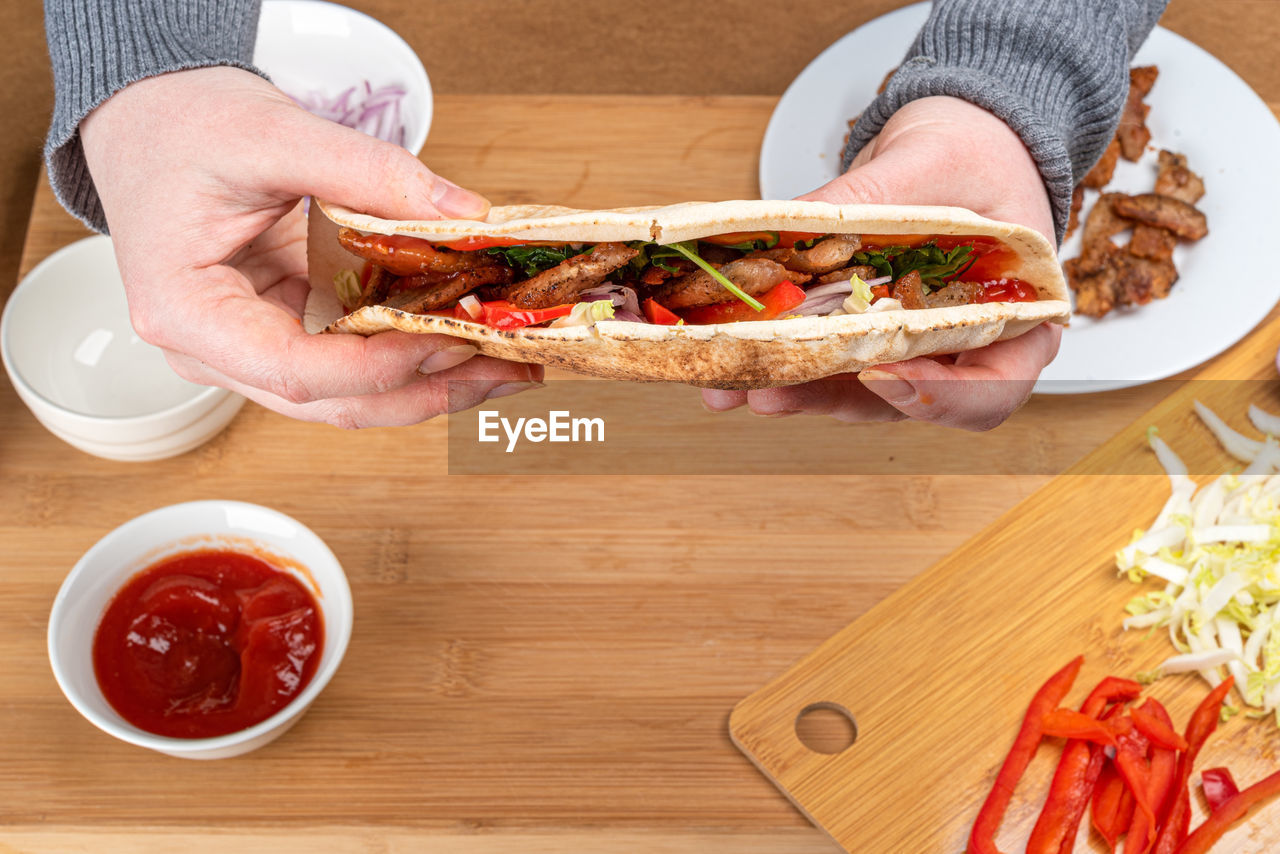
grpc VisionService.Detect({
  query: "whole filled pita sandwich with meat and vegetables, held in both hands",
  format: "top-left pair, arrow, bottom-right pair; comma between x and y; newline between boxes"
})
305,201 -> 1070,388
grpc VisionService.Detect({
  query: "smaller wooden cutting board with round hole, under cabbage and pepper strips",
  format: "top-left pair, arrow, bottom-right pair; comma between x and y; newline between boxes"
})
730,321 -> 1280,854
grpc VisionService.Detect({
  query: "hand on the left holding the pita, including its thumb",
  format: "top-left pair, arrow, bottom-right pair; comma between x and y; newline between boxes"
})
81,68 -> 543,428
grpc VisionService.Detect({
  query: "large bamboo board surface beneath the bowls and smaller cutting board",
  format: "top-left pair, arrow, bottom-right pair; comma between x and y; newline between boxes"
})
0,0 -> 1280,853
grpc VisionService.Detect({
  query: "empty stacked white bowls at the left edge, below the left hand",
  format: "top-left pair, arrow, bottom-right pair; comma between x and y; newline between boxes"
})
0,237 -> 244,461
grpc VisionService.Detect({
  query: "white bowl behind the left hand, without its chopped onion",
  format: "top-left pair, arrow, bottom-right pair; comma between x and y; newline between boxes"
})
253,0 -> 433,155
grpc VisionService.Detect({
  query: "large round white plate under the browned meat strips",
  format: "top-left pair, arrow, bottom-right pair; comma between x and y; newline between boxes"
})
760,3 -> 1280,394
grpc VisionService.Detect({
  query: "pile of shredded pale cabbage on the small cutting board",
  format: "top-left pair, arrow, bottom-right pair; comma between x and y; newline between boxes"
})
1116,401 -> 1280,725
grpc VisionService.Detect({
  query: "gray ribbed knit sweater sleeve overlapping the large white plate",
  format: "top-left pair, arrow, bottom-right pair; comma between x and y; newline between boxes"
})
844,0 -> 1169,241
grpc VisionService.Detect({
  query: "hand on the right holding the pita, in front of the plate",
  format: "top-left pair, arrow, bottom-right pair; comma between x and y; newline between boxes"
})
703,96 -> 1062,430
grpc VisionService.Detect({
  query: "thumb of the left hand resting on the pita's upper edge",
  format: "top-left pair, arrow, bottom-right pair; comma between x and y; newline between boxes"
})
269,109 -> 489,219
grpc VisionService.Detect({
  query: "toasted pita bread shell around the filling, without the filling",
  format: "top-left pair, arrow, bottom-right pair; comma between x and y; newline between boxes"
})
305,201 -> 1071,388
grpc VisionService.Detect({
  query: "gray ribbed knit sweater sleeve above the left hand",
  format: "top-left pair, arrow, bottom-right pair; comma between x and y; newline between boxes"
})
45,0 -> 261,232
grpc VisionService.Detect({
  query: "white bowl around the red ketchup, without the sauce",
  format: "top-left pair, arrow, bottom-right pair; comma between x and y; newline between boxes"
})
49,501 -> 352,759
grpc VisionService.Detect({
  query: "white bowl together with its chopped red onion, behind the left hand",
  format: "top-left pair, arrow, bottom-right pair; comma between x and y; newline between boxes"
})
253,0 -> 433,155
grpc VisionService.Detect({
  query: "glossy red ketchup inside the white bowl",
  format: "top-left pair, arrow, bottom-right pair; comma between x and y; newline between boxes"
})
93,551 -> 324,739
